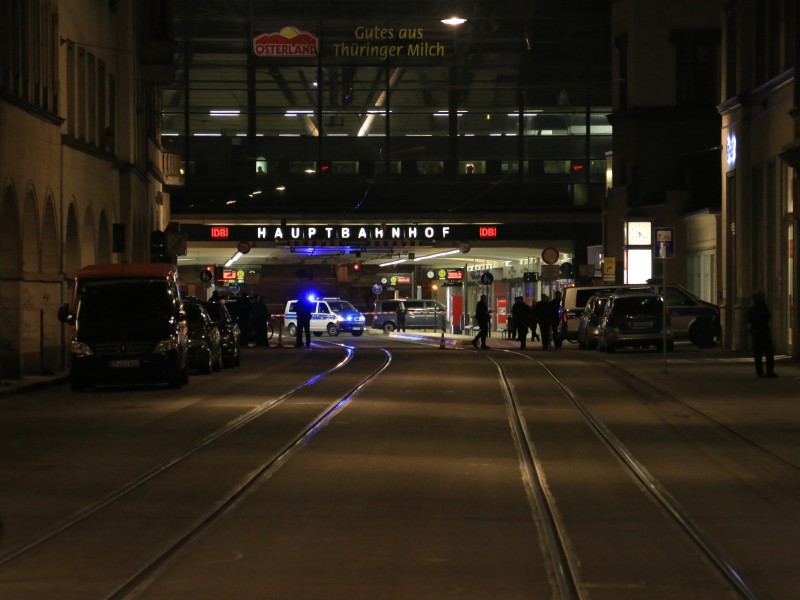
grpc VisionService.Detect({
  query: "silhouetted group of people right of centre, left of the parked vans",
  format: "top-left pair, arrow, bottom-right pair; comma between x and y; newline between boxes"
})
472,292 -> 562,350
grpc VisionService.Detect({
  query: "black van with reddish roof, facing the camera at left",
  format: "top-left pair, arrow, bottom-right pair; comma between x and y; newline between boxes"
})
58,263 -> 189,391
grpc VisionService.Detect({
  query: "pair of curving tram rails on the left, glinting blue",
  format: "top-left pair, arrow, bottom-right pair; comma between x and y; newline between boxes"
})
0,345 -> 392,598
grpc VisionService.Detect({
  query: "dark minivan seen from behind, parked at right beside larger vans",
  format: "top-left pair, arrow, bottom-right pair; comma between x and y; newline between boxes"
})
597,292 -> 673,352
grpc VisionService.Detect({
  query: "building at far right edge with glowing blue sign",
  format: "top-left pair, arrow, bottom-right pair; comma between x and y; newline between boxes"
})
720,0 -> 798,357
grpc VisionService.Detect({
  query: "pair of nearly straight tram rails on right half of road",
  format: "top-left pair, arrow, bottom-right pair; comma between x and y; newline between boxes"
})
490,352 -> 763,600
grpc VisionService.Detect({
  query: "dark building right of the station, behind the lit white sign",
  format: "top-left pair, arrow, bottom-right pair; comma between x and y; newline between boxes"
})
604,0 -> 722,296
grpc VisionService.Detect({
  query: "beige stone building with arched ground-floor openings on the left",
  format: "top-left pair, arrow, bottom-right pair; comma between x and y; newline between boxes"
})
0,0 -> 168,379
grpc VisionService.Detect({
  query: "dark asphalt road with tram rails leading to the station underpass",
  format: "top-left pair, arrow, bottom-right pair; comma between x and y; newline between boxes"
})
0,332 -> 800,600
